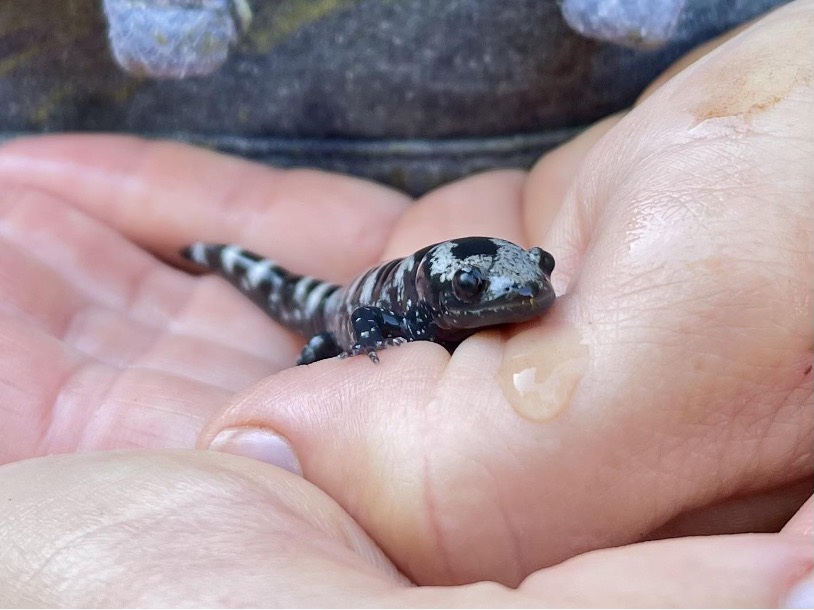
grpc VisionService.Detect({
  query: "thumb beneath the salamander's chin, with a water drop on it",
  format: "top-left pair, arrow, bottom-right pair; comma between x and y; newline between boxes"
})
200,314 -> 664,585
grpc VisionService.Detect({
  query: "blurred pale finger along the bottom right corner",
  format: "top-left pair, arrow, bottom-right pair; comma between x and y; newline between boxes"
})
519,535 -> 814,608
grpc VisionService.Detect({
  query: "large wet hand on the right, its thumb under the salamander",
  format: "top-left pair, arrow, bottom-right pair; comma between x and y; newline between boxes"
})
200,3 -> 814,584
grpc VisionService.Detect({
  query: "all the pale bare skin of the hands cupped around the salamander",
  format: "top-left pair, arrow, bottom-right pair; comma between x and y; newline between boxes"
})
0,1 -> 814,607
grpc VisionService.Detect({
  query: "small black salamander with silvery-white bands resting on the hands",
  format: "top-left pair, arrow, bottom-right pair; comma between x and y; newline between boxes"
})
182,237 -> 554,364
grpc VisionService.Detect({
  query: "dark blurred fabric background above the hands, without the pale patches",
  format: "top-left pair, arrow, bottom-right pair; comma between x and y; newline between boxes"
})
0,0 -> 784,193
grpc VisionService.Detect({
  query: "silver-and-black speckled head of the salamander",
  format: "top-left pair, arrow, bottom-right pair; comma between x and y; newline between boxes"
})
416,237 -> 554,330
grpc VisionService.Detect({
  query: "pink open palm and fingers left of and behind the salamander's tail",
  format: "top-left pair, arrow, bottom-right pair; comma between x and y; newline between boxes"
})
0,138 -> 414,454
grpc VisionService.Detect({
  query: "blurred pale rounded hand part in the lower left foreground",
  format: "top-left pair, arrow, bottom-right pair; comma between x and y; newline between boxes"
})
0,452 -> 404,607
